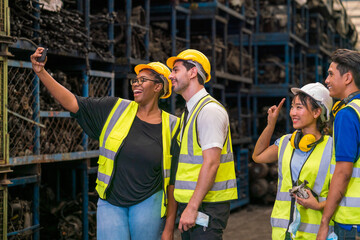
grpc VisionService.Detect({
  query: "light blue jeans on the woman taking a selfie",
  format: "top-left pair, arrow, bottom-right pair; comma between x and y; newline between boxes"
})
96,191 -> 165,240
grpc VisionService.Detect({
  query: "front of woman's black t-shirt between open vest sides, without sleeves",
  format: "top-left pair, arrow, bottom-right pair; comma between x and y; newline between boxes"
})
106,117 -> 163,206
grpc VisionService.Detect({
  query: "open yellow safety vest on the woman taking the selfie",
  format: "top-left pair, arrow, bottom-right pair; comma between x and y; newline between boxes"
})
96,98 -> 180,217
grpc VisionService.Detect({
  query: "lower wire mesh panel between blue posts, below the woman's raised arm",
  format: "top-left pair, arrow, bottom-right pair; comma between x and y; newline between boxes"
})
40,117 -> 84,154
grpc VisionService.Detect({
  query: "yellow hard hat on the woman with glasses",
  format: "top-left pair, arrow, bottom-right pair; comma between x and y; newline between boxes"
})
134,62 -> 172,99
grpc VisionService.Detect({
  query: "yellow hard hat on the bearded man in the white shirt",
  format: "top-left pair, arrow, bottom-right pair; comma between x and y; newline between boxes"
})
166,49 -> 211,82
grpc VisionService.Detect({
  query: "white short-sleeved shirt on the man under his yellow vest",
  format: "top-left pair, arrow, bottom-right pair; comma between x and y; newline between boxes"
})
180,88 -> 229,151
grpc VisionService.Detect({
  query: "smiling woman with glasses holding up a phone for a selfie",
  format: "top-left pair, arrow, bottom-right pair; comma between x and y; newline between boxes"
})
30,48 -> 179,240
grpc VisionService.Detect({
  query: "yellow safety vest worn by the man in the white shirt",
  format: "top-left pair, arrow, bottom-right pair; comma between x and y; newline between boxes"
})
174,95 -> 238,203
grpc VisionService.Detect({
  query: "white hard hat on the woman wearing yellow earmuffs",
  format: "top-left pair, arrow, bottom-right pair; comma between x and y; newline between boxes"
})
291,82 -> 333,122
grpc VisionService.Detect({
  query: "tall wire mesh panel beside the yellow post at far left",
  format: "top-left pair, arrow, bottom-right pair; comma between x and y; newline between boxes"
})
8,67 -> 38,157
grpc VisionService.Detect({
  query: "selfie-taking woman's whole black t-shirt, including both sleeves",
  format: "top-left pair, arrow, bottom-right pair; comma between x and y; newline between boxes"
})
71,96 -> 179,206
